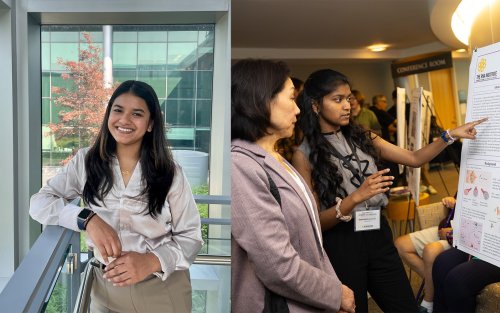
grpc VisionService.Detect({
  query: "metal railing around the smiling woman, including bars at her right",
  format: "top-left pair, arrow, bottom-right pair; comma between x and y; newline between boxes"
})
0,195 -> 231,313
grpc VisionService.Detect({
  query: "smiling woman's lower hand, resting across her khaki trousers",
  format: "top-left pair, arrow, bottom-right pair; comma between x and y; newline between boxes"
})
103,252 -> 161,287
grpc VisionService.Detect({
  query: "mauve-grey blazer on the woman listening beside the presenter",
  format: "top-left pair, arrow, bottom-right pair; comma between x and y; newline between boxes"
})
231,140 -> 342,313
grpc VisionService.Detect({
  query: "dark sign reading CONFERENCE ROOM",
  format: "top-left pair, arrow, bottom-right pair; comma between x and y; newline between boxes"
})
391,52 -> 453,78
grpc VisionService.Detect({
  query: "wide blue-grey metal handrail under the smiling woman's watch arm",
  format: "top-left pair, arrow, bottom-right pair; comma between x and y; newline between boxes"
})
0,225 -> 75,313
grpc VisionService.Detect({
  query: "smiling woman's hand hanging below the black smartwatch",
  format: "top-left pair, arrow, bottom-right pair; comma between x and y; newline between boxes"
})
87,214 -> 122,262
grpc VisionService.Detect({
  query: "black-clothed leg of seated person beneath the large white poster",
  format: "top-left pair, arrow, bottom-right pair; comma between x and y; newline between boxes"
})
432,248 -> 500,313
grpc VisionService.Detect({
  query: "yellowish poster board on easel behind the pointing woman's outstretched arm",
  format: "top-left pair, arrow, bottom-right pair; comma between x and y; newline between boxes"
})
406,87 -> 434,206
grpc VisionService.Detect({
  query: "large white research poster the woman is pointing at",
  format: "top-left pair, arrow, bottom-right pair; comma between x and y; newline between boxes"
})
453,43 -> 500,266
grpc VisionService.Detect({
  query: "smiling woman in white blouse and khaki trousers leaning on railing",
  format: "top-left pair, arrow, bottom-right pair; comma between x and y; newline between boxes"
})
30,81 -> 202,313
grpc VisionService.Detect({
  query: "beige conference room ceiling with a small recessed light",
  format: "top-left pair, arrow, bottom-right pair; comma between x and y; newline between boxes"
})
231,0 -> 460,63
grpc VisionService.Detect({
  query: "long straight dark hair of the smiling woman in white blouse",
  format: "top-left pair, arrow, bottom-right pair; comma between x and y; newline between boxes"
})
83,80 -> 175,218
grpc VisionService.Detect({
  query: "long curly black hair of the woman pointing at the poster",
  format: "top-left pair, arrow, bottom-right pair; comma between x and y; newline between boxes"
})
298,69 -> 378,207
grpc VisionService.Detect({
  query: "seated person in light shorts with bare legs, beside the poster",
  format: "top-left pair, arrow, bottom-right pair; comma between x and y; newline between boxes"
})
394,197 -> 455,313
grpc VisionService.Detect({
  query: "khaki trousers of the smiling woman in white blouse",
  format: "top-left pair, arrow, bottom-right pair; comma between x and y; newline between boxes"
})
90,267 -> 191,313
